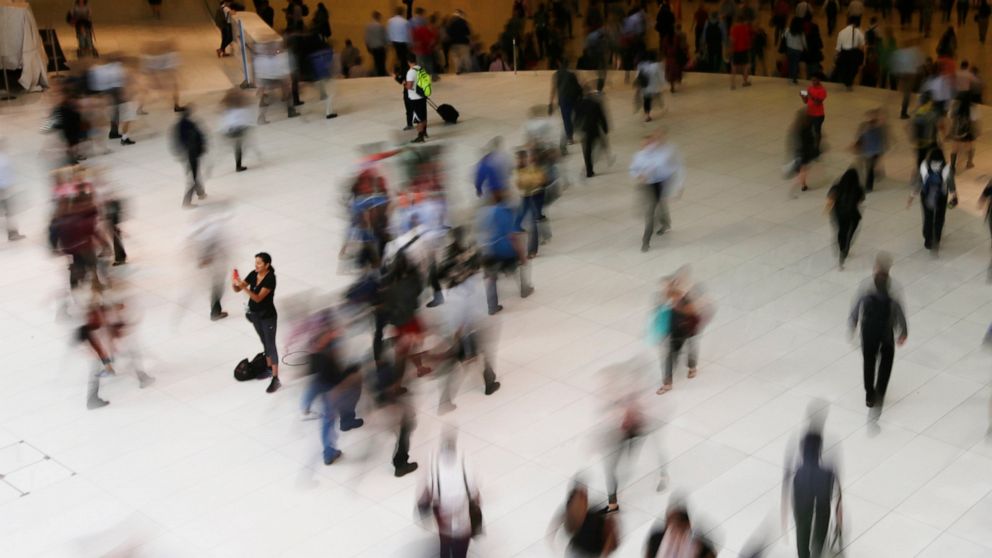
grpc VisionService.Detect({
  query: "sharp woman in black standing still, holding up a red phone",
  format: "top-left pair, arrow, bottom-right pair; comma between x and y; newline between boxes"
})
232,252 -> 282,393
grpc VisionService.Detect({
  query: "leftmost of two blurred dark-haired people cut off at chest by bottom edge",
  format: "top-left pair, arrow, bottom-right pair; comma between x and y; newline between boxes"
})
546,484 -> 620,558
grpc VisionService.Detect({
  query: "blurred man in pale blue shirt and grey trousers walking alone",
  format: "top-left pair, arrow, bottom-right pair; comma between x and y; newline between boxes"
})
630,132 -> 684,252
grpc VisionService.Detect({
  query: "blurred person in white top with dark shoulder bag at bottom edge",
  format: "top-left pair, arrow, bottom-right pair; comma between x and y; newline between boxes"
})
417,430 -> 482,558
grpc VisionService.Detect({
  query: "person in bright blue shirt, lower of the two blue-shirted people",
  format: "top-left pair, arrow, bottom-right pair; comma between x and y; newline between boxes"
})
478,190 -> 534,315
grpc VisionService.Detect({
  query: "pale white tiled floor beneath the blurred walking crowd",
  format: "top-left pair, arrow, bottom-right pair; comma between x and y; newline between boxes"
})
0,61 -> 992,558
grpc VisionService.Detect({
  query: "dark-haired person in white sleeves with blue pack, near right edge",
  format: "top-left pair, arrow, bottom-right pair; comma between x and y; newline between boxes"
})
906,148 -> 958,256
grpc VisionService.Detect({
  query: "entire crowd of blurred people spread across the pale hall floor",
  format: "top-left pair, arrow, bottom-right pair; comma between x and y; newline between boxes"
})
0,0 -> 992,557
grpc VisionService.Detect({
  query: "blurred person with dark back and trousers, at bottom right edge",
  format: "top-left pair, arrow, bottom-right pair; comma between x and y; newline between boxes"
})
782,431 -> 844,558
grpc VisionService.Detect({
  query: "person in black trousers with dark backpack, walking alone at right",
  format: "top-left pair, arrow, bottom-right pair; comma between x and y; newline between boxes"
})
850,265 -> 909,417
